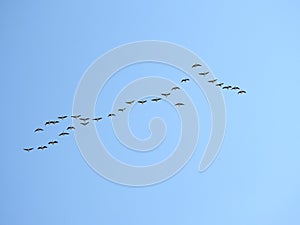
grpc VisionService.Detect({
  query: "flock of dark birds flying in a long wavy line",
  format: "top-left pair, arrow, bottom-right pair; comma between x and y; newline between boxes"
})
23,63 -> 246,152
